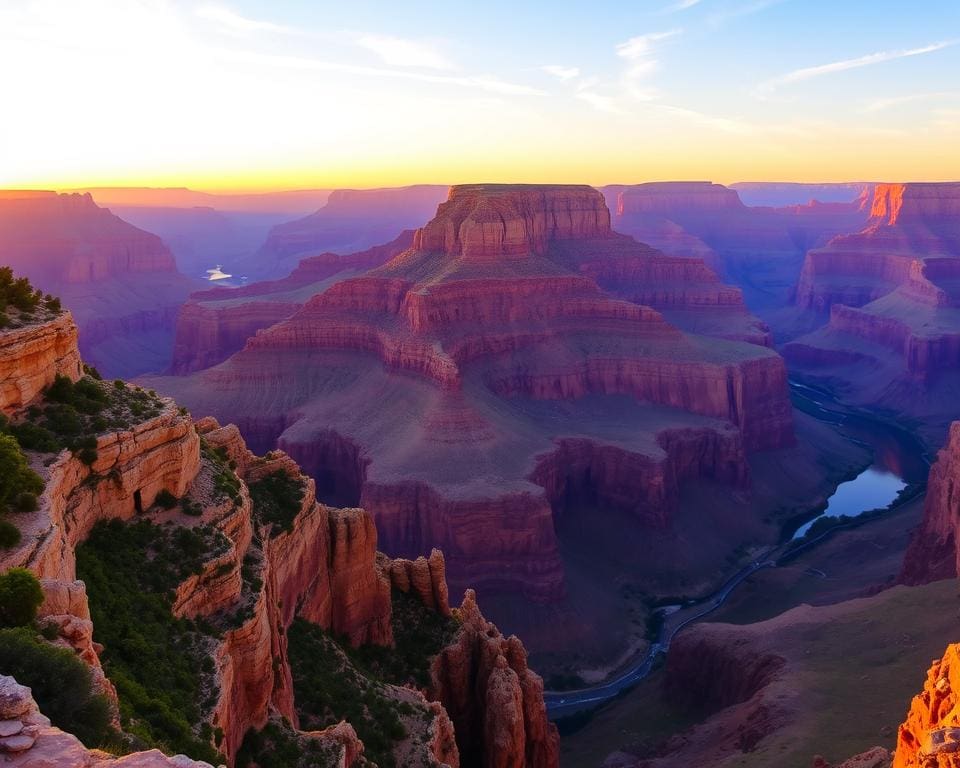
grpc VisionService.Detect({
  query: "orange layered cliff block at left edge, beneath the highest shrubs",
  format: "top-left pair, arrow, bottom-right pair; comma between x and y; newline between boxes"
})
0,312 -> 83,414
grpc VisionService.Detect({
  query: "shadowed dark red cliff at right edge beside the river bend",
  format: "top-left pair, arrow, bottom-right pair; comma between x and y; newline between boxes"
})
899,421 -> 960,584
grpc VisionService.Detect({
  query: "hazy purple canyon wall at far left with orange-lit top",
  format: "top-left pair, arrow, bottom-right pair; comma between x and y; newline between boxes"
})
0,191 -> 194,376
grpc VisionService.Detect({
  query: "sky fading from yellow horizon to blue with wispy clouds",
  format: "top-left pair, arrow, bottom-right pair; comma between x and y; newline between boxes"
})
0,0 -> 960,191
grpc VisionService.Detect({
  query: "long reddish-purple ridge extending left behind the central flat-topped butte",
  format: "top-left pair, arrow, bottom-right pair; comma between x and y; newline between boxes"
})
170,230 -> 413,375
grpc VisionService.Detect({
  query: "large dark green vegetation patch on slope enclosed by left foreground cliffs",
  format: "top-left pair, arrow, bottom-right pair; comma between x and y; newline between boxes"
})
77,520 -> 229,764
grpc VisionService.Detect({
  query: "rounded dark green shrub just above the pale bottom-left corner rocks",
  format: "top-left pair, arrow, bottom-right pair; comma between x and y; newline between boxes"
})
0,628 -> 111,747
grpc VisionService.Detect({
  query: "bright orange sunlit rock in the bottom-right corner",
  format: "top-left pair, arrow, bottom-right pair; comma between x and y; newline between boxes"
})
893,644 -> 960,768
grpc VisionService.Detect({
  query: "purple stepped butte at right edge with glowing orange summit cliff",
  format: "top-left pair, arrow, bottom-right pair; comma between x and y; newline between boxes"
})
783,183 -> 960,445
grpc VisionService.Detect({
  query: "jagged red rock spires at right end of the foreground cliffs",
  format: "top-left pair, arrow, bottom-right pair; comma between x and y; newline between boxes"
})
428,590 -> 560,768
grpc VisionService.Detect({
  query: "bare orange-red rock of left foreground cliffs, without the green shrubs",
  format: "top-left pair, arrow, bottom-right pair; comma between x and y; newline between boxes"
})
0,314 -> 558,768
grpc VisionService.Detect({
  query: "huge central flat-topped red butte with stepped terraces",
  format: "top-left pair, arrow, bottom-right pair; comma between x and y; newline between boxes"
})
141,185 -> 793,600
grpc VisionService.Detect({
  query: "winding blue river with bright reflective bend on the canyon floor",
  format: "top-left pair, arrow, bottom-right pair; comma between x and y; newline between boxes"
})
544,381 -> 930,719
